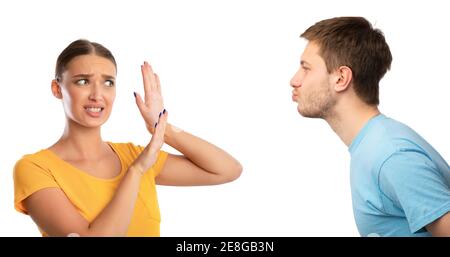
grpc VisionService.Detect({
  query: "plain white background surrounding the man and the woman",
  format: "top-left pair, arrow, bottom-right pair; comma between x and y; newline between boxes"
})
0,0 -> 450,236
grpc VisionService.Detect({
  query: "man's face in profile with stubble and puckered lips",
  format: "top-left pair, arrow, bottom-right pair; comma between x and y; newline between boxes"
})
290,42 -> 336,118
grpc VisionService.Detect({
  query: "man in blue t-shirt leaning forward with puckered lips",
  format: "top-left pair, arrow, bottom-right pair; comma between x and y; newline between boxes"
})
291,17 -> 450,236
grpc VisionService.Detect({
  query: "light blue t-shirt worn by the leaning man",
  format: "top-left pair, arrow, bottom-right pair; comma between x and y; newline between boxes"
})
349,114 -> 450,236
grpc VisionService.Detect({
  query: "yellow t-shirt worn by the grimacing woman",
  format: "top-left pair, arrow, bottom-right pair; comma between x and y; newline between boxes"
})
14,142 -> 167,236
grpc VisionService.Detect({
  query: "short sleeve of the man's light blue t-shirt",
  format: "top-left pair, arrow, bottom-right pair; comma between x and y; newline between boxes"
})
379,151 -> 450,233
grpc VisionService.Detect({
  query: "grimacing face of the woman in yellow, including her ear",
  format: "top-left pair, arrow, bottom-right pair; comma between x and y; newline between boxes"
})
52,55 -> 116,127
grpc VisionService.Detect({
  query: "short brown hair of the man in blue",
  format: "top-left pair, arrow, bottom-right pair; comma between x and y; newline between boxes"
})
300,17 -> 392,105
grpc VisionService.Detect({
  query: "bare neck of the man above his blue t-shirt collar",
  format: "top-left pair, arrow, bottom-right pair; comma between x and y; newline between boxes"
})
325,99 -> 380,146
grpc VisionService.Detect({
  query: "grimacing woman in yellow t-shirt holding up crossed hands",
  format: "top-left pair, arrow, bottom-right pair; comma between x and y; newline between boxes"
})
14,40 -> 242,236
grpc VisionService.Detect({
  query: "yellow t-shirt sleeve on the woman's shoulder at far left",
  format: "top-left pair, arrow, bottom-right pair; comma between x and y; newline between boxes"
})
13,158 -> 59,214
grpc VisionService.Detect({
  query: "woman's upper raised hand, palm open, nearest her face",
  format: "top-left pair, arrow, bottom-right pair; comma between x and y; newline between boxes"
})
134,62 -> 164,134
